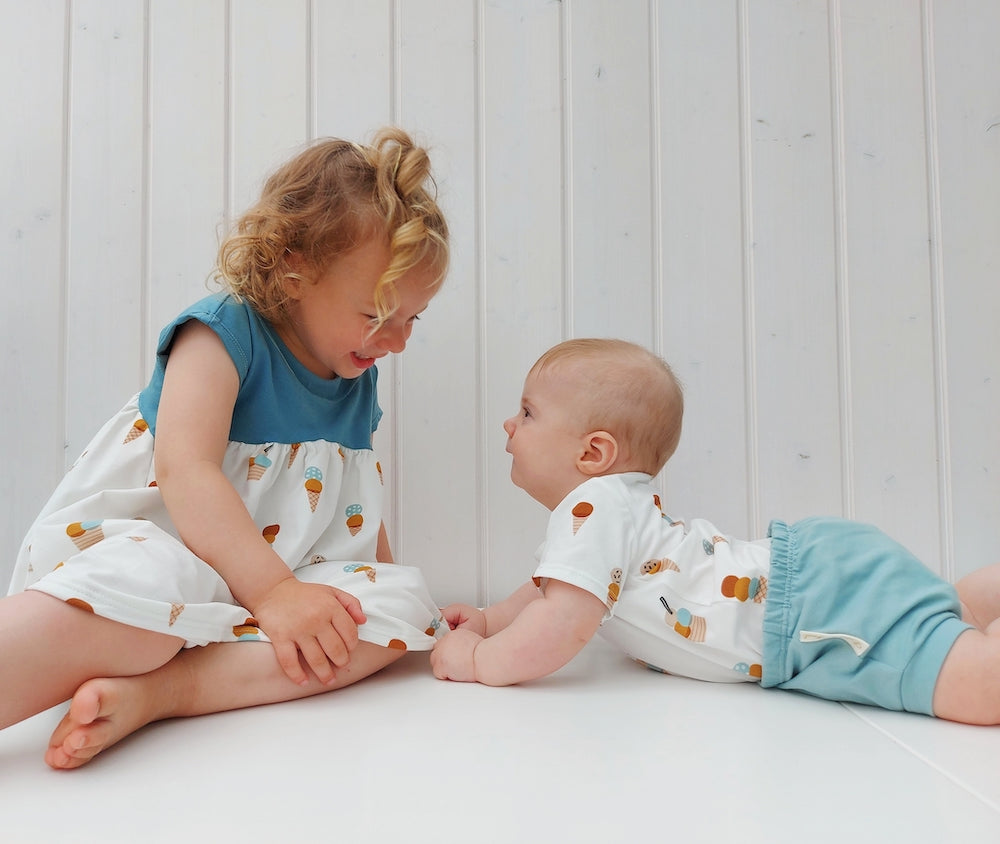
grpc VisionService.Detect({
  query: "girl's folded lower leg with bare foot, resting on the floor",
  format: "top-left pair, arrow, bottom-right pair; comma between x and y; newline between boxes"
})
45,642 -> 404,768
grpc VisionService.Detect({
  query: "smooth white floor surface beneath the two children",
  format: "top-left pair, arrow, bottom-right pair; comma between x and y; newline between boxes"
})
0,640 -> 1000,844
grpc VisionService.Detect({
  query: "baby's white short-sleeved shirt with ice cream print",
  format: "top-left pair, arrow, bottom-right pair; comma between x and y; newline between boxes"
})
534,472 -> 770,682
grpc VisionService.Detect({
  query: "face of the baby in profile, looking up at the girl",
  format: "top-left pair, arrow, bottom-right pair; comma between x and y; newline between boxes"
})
503,372 -> 586,510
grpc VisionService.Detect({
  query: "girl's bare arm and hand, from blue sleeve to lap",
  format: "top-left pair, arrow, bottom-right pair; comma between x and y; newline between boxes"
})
154,322 -> 364,683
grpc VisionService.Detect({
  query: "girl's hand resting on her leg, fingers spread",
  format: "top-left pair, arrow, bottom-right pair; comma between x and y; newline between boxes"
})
252,577 -> 365,685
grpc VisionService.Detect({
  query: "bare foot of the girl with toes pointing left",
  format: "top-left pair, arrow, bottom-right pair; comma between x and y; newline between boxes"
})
45,677 -> 158,769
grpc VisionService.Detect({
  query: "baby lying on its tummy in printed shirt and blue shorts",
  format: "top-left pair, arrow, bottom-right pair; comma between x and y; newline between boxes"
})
431,339 -> 1000,724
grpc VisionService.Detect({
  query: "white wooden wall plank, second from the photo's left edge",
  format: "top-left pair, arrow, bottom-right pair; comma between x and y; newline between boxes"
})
66,0 -> 148,467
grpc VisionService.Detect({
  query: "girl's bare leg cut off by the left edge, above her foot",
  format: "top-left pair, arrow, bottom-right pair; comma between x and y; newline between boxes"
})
0,591 -> 183,728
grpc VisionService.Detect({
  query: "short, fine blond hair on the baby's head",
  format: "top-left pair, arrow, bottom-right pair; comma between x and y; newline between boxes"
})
531,338 -> 684,475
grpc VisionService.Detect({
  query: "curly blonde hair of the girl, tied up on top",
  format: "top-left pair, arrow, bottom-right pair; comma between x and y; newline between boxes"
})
214,127 -> 449,329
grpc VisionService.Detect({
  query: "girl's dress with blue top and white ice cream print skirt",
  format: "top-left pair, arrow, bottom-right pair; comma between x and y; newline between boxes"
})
10,294 -> 447,650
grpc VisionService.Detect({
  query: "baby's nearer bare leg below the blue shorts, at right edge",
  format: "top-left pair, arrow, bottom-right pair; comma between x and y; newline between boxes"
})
933,625 -> 1000,724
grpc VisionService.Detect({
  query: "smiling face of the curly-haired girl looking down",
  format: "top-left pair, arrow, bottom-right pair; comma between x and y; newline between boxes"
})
276,239 -> 439,378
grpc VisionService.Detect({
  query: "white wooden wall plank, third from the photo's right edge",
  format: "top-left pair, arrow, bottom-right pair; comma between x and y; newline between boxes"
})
747,0 -> 843,530
